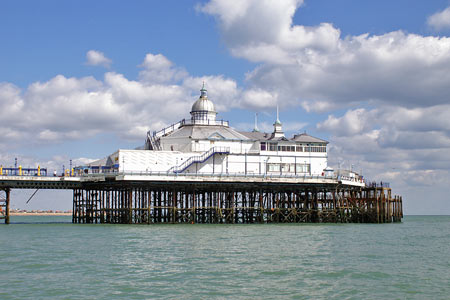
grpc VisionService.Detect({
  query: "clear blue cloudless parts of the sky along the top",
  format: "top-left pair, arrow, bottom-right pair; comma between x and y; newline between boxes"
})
0,0 -> 449,87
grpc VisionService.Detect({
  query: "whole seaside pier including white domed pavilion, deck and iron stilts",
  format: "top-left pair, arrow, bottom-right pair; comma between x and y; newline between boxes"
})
0,83 -> 403,224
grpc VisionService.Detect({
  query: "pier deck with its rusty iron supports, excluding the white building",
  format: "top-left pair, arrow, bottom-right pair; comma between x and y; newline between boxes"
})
0,173 -> 403,224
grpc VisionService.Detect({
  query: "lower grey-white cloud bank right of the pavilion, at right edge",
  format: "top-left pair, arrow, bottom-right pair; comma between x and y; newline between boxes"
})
317,104 -> 450,186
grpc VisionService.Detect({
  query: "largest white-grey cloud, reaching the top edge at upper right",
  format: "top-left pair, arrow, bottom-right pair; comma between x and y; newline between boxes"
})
199,0 -> 450,112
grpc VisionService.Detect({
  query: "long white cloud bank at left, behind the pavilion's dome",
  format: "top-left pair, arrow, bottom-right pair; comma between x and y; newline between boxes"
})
0,54 -> 239,150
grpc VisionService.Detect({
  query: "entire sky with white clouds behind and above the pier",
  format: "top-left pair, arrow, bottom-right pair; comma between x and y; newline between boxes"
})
0,0 -> 450,214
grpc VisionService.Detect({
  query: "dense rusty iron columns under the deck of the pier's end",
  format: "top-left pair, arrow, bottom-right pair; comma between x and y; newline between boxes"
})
72,182 -> 403,224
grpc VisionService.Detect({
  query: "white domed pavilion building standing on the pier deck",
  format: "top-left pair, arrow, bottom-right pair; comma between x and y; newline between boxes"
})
79,87 -> 328,176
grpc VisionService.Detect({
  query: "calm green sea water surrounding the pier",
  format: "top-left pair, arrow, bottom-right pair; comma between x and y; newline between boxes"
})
0,216 -> 450,299
